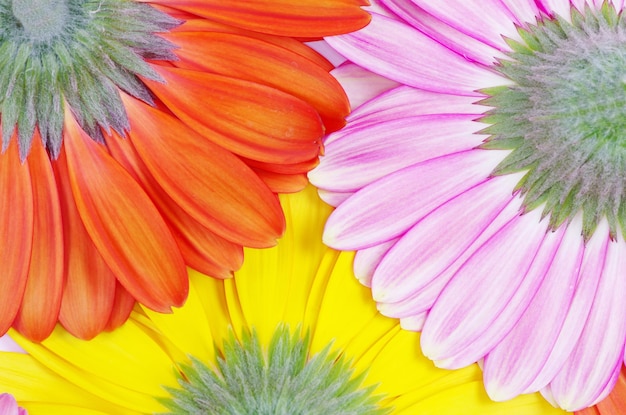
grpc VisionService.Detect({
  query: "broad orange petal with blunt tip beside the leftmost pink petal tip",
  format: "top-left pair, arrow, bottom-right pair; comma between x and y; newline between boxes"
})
144,65 -> 323,164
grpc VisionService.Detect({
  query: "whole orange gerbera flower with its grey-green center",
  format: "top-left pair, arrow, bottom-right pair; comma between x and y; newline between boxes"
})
0,0 -> 368,341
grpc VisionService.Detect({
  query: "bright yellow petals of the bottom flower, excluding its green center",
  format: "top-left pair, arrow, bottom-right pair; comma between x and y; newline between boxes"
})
0,187 -> 562,415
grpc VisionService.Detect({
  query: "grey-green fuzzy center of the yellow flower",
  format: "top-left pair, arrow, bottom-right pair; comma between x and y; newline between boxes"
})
163,326 -> 388,415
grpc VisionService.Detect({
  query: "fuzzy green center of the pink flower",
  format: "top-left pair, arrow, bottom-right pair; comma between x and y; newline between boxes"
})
481,2 -> 626,238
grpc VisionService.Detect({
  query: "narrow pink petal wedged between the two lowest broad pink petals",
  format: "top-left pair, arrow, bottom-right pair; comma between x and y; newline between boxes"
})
525,221 -> 609,393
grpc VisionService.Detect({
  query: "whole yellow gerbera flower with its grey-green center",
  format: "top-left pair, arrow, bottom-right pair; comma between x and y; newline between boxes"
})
0,187 -> 562,415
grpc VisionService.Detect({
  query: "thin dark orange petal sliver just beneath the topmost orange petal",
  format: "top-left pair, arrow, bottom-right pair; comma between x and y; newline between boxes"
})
172,19 -> 335,72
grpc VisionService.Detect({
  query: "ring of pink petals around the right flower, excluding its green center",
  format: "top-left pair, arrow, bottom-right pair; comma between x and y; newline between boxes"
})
309,0 -> 626,413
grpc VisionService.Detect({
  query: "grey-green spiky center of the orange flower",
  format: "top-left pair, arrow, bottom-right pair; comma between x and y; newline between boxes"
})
0,0 -> 180,158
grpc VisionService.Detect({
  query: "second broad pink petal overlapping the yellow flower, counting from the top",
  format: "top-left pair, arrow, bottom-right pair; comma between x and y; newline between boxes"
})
372,175 -> 519,306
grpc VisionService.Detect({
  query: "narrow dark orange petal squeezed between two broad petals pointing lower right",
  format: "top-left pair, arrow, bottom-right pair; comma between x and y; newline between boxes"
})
105,127 -> 243,278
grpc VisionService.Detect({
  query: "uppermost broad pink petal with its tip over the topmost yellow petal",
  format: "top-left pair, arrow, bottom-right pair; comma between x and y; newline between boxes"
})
323,150 -> 508,251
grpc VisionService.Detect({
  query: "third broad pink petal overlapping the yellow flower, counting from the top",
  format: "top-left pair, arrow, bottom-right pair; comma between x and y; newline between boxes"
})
421,209 -> 547,369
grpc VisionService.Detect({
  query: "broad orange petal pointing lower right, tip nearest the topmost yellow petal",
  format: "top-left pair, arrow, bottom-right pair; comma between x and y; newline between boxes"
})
122,95 -> 285,248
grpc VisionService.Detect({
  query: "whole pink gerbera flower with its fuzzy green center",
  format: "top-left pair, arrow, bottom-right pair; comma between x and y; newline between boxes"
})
310,0 -> 626,410
